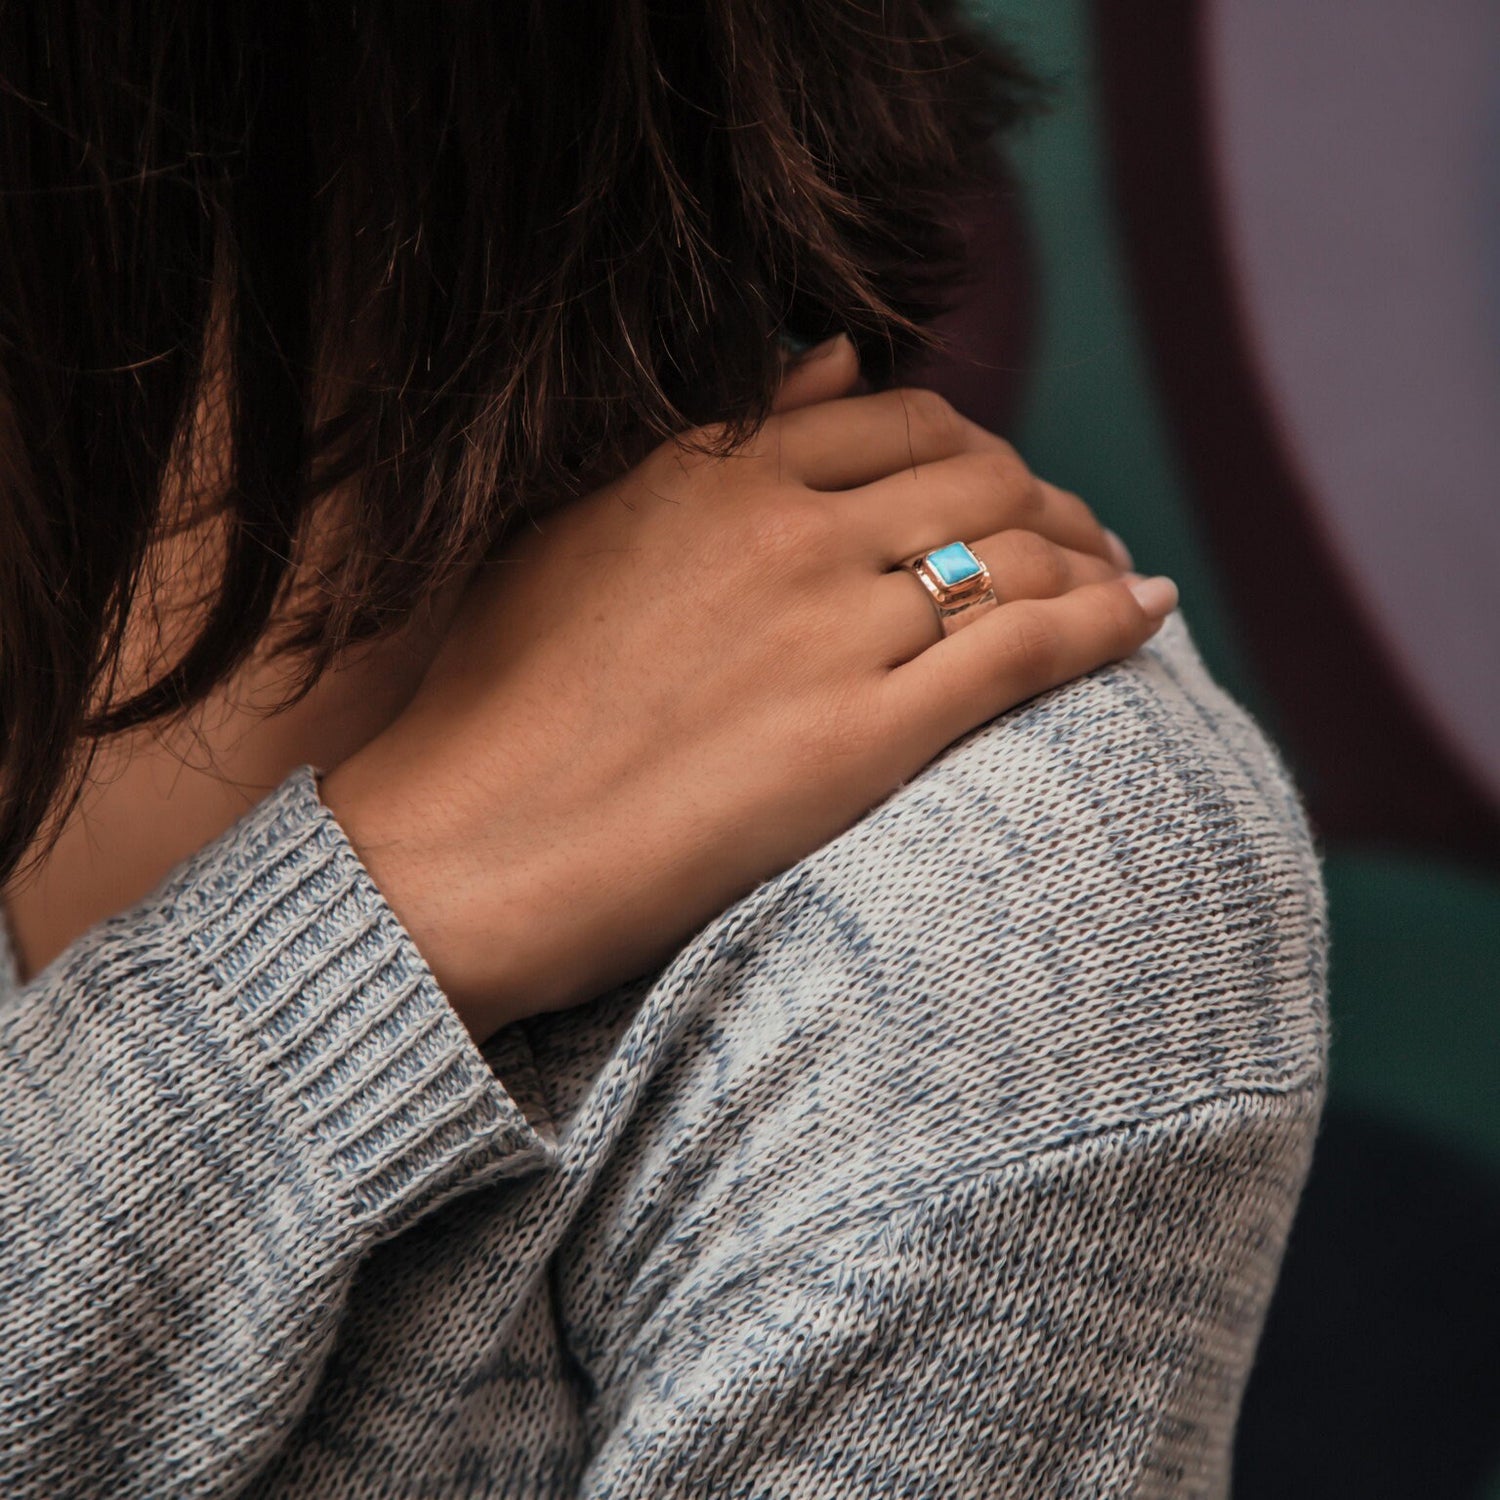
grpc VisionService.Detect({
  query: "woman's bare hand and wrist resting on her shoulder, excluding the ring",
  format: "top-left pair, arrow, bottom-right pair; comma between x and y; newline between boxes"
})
323,341 -> 1176,1040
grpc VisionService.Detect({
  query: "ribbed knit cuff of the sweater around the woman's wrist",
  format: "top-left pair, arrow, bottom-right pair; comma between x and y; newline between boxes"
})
173,767 -> 555,1238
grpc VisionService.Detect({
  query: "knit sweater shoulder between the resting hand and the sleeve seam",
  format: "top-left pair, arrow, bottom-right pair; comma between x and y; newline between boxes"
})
530,617 -> 1326,1223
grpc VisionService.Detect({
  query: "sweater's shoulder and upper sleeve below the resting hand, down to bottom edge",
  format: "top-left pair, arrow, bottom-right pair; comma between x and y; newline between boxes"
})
549,617 -> 1328,1500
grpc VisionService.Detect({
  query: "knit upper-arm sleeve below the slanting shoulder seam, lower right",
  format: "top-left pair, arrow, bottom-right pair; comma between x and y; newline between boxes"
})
581,1085 -> 1322,1500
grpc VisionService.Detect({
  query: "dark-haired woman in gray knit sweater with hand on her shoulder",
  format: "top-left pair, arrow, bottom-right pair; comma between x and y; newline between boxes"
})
0,0 -> 1323,1497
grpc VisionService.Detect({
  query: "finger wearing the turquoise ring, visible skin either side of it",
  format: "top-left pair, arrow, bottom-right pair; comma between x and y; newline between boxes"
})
875,530 -> 1121,666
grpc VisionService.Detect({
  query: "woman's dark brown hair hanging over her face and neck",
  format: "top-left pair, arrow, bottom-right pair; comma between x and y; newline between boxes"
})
0,0 -> 1029,881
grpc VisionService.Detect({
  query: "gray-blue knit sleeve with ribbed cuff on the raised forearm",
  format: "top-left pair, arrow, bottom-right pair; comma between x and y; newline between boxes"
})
0,767 -> 555,1500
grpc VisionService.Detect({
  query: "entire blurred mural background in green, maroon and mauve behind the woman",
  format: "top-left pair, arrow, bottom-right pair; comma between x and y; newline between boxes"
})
912,0 -> 1500,1500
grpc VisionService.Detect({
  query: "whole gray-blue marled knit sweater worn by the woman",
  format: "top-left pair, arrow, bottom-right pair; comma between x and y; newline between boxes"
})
0,617 -> 1326,1500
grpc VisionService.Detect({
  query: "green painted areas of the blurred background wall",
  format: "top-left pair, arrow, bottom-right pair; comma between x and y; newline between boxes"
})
977,0 -> 1500,1500
